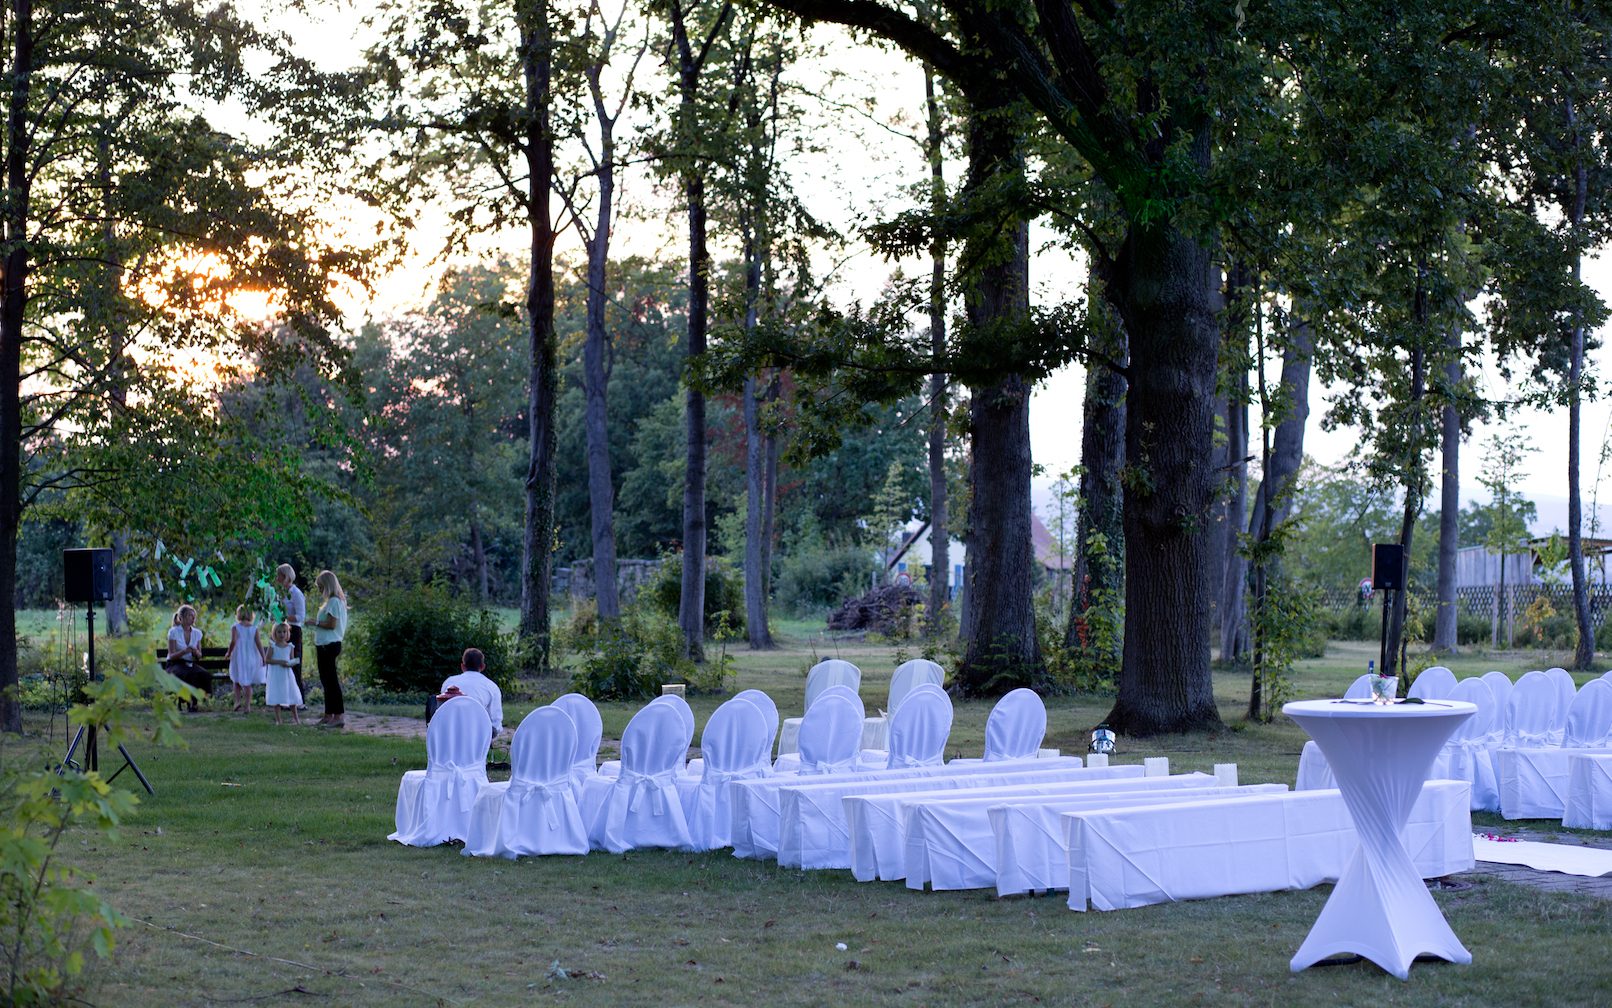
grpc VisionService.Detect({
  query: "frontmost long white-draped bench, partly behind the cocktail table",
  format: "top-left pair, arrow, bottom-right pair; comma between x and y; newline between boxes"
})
1062,781 -> 1473,916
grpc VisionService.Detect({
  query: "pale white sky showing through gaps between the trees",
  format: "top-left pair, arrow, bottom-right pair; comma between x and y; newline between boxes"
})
266,0 -> 1612,534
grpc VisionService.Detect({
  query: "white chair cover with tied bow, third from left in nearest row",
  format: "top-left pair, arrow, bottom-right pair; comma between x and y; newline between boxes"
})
584,702 -> 693,853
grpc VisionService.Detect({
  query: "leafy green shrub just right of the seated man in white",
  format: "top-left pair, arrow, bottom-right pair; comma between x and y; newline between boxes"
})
561,605 -> 699,700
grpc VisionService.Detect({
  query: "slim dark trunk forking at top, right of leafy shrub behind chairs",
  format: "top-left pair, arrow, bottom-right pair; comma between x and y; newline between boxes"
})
671,3 -> 725,661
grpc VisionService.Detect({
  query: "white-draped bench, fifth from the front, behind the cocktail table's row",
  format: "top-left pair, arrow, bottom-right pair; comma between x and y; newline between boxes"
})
777,763 -> 1136,868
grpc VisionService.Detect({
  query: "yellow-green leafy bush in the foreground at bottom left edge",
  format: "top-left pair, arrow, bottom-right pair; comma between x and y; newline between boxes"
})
0,660 -> 193,1005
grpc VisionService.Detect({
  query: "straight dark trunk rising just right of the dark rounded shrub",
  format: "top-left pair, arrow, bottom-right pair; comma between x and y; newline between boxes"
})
516,0 -> 558,674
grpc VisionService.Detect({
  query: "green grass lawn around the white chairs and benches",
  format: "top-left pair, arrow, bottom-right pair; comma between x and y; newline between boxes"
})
22,634 -> 1612,1008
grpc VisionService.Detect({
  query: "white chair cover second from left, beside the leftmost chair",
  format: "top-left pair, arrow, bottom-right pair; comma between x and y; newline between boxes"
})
464,706 -> 588,858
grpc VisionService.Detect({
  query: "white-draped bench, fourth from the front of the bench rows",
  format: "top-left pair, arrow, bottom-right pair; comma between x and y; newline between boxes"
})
841,763 -> 1214,882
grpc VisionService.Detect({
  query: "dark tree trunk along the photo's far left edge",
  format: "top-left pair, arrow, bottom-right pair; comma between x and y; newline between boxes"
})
0,0 -> 34,732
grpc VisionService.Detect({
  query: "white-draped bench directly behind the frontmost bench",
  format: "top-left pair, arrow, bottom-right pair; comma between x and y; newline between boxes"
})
980,777 -> 1288,897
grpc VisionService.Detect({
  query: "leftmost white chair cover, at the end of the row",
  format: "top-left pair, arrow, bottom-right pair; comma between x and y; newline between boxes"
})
387,697 -> 493,847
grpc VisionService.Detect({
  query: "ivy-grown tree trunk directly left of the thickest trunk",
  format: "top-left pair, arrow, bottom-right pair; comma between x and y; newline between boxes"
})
1064,287 -> 1130,660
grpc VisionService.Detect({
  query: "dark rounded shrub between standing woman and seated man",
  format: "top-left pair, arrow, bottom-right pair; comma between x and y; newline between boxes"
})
343,585 -> 519,694
